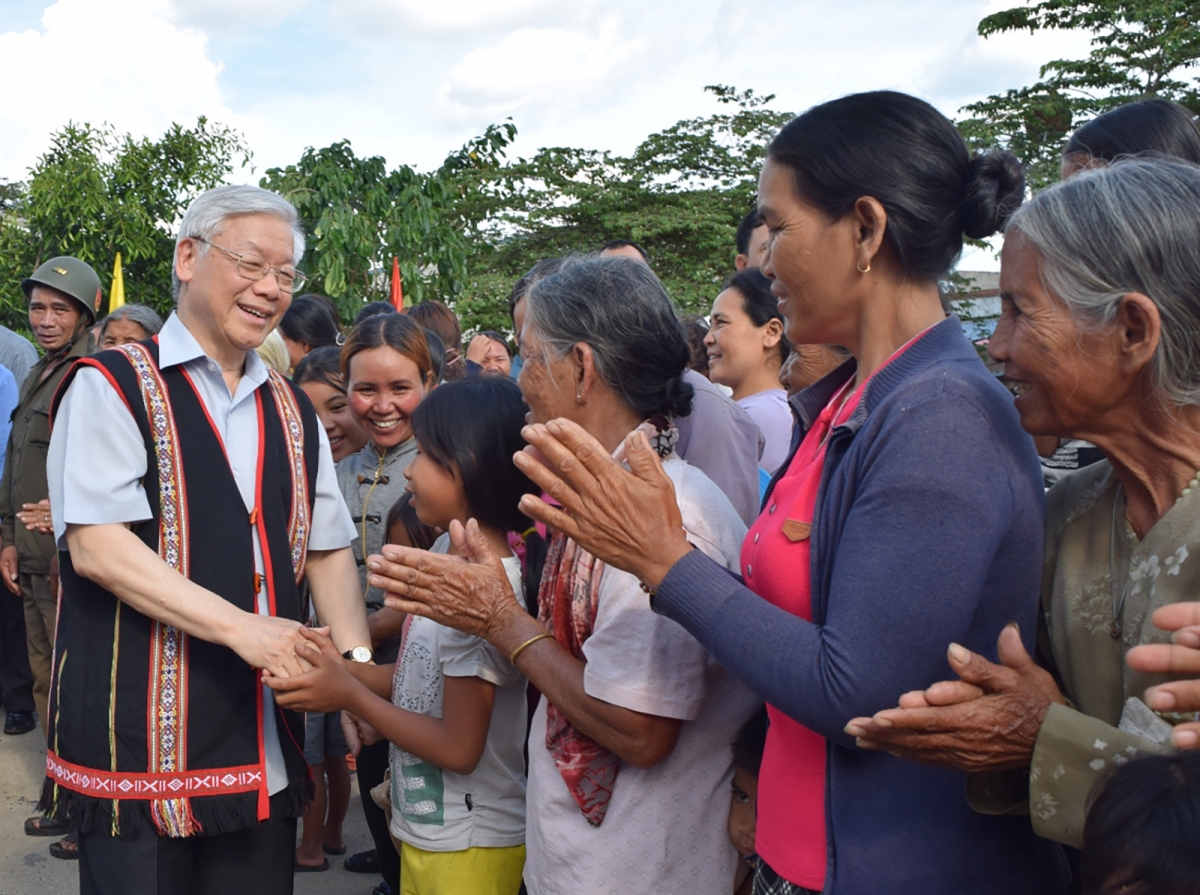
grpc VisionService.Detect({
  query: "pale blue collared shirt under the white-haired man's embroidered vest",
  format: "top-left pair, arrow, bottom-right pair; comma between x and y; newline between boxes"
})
46,314 -> 354,795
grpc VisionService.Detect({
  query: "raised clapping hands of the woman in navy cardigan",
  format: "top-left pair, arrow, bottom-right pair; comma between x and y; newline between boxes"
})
514,420 -> 691,587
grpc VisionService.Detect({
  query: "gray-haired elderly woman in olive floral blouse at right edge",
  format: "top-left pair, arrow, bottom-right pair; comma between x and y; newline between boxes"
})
847,158 -> 1200,846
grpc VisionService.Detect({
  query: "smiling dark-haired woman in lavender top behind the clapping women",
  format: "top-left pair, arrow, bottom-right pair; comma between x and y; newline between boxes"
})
704,269 -> 792,473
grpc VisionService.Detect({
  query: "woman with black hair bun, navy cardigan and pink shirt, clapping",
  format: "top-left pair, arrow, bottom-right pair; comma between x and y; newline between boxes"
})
377,91 -> 1068,895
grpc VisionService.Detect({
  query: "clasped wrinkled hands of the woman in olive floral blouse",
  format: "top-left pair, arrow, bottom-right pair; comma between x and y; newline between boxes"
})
846,625 -> 1066,771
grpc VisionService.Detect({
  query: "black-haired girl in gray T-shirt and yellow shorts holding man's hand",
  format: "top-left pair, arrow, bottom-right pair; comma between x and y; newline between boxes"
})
270,377 -> 538,895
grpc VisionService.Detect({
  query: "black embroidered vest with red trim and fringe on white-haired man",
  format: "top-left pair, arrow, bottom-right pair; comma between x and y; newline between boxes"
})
43,342 -> 319,836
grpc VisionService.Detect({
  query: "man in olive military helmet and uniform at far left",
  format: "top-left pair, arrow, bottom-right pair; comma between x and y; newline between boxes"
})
0,257 -> 101,734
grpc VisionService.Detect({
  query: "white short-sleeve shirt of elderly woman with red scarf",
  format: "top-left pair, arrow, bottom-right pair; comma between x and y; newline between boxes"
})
524,457 -> 760,895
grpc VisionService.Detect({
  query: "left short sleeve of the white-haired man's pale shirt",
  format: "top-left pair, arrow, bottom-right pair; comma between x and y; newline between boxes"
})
46,367 -> 152,549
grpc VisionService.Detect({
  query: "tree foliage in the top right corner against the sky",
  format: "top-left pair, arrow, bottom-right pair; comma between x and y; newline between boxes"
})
959,0 -> 1200,190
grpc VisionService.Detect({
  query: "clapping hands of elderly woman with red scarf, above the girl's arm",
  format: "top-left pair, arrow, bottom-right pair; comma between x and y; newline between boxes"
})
367,519 -> 524,641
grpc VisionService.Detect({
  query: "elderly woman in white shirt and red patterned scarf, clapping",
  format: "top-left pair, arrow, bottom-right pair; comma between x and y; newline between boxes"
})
371,258 -> 757,895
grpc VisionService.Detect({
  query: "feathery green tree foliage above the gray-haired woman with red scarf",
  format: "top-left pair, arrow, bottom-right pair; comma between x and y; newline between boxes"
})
448,86 -> 792,329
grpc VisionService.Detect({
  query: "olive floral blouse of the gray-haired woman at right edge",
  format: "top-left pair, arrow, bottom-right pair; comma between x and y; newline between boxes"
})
970,461 -> 1200,847
